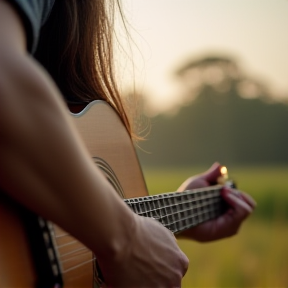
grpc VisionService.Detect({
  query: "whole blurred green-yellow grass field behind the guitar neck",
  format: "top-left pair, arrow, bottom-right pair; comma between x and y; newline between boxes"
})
144,167 -> 288,288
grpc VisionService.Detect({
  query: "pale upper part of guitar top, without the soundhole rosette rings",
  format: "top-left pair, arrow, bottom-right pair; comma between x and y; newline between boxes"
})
73,101 -> 147,198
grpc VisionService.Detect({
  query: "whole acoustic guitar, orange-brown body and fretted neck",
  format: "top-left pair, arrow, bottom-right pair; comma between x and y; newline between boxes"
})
0,101 -> 227,288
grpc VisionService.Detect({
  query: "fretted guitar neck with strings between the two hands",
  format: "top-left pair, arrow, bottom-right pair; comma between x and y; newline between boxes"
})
124,185 -> 227,234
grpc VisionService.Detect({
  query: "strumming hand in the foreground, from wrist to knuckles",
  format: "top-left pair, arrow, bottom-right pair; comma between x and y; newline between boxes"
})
99,215 -> 188,287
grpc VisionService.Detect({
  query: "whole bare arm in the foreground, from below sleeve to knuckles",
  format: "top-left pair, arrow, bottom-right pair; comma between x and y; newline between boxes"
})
0,0 -> 188,287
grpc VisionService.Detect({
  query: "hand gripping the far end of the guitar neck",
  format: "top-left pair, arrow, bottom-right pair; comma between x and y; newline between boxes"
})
178,163 -> 256,242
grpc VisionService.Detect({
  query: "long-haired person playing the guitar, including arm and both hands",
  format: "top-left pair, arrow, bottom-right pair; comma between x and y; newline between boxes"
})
0,0 -> 255,287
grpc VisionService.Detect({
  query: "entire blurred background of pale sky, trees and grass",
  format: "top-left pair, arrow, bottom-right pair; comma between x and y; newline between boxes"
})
116,0 -> 288,287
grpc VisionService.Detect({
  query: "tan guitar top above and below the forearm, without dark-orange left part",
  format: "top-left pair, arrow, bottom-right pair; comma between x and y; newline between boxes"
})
54,101 -> 147,288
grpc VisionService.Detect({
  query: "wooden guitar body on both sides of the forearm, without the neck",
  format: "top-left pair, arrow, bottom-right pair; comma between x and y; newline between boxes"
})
0,101 -> 147,288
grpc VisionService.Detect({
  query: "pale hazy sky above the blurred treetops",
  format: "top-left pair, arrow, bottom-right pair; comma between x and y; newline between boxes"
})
119,0 -> 288,110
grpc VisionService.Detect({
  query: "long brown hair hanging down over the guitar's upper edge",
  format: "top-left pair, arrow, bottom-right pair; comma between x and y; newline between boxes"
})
35,0 -> 133,136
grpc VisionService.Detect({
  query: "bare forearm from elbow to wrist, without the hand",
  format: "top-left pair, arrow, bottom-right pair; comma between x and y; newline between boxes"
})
0,54 -> 133,258
